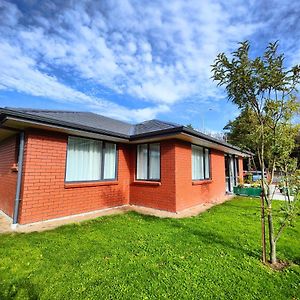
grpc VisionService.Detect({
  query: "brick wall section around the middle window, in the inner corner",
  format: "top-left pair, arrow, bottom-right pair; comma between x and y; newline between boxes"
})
130,140 -> 176,212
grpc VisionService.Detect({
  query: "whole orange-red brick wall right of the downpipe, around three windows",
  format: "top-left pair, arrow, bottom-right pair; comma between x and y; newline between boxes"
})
16,130 -> 242,224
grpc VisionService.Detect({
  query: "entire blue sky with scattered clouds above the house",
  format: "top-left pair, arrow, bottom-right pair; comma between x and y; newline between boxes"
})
0,0 -> 300,132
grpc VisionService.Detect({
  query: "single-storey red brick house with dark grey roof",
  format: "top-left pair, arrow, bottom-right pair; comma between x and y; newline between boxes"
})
0,108 -> 249,224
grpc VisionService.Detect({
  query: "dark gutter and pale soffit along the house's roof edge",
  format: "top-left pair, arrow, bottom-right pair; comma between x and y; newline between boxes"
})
0,109 -> 253,157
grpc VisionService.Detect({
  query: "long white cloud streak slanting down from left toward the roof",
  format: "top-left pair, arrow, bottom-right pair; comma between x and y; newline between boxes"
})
0,43 -> 168,121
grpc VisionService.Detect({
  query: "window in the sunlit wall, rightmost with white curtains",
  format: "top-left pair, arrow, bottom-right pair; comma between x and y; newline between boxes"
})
192,145 -> 210,180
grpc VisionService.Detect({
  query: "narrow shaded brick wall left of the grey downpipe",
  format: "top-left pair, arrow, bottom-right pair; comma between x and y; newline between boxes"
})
0,135 -> 18,217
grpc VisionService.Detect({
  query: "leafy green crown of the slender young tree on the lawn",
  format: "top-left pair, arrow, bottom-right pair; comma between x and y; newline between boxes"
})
212,42 -> 300,178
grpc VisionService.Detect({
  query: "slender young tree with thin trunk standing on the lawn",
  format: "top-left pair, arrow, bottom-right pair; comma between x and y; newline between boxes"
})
212,41 -> 300,264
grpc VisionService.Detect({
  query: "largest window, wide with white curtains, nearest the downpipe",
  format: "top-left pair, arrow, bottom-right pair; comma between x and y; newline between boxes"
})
66,137 -> 117,182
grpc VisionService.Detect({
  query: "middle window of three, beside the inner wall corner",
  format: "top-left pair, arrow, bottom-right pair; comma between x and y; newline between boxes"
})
136,143 -> 160,180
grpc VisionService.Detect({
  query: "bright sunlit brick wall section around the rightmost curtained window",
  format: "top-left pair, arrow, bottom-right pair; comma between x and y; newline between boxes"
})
175,141 -> 225,211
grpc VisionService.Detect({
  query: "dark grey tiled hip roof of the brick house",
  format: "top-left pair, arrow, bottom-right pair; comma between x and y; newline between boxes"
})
0,107 -> 252,155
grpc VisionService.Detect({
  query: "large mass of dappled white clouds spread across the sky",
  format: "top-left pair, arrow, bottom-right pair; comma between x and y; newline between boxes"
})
0,0 -> 298,120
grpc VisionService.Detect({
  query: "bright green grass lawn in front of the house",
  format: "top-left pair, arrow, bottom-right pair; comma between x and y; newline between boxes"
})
0,197 -> 300,300
